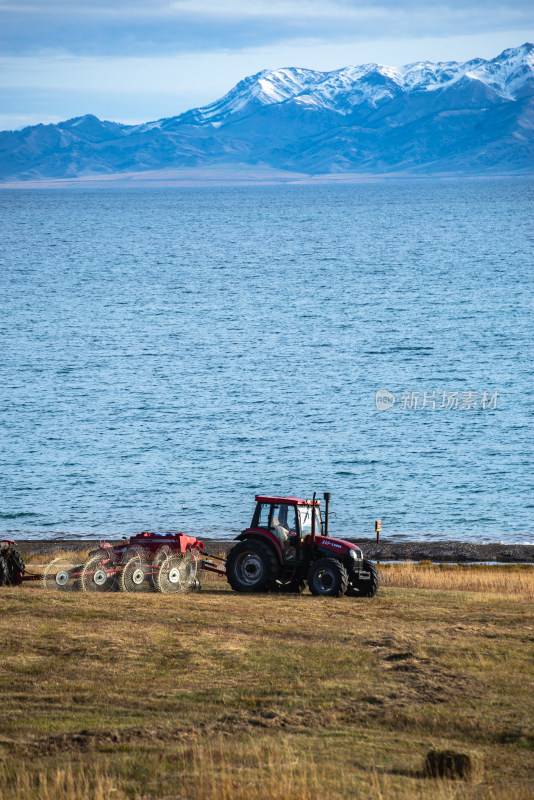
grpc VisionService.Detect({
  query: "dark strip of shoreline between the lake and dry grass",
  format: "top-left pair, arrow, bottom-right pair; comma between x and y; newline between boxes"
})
15,539 -> 534,564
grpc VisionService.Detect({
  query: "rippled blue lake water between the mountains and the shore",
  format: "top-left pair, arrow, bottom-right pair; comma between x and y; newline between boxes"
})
0,181 -> 534,542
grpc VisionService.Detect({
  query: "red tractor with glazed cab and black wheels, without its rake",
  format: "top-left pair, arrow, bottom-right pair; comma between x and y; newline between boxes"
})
226,492 -> 380,597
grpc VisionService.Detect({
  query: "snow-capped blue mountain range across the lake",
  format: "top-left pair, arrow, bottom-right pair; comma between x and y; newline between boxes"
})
0,44 -> 534,182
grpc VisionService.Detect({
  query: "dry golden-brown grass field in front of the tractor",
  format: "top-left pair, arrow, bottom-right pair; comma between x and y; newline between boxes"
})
0,564 -> 534,800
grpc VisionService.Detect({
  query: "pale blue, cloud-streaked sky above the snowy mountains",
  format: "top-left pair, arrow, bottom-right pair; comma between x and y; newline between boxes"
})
0,0 -> 534,129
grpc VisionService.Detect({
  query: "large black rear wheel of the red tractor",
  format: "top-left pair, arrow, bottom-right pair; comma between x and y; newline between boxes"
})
226,539 -> 280,592
